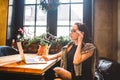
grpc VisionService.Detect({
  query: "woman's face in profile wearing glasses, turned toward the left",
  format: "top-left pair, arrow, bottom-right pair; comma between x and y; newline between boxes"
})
70,25 -> 78,40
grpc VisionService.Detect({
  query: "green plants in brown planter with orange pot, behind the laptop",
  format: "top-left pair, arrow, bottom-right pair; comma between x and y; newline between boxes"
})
23,33 -> 56,55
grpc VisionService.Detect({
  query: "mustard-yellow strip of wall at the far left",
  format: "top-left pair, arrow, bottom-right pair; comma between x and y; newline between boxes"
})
0,0 -> 8,46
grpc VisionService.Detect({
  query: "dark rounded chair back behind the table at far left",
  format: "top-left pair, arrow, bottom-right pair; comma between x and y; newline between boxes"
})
0,46 -> 19,56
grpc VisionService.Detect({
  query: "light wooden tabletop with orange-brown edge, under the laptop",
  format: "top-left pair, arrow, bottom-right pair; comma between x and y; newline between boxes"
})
0,54 -> 58,75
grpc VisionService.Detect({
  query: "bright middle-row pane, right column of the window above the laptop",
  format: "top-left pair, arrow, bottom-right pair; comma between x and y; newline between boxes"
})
36,6 -> 47,25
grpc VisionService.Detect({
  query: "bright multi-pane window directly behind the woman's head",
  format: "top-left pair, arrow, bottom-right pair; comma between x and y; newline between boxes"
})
57,0 -> 83,36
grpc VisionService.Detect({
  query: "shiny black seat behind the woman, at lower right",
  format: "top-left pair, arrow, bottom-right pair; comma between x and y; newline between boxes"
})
96,57 -> 120,80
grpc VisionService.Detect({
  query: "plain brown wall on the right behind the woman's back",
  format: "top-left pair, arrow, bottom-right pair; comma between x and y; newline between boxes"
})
94,0 -> 117,60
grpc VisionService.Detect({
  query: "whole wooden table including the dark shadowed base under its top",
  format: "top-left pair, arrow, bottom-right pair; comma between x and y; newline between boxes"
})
0,53 -> 60,80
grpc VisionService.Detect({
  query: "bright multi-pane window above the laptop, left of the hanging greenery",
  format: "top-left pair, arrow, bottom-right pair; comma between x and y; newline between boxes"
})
24,0 -> 47,37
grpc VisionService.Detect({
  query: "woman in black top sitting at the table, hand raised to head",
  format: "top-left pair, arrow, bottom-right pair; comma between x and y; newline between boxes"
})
43,23 -> 96,80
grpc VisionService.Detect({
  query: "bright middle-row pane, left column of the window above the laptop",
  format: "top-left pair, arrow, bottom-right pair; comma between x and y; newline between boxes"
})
24,6 -> 35,25
